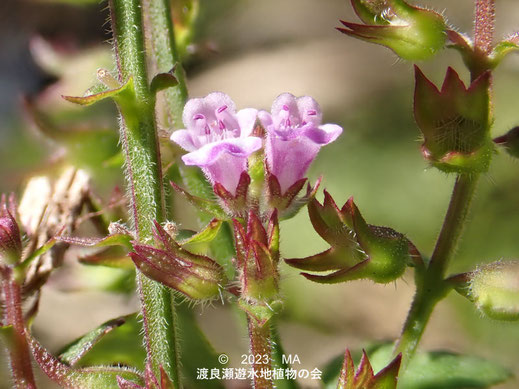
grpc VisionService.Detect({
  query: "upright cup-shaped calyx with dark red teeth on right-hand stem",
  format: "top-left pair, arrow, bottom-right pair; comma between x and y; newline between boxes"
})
414,67 -> 494,173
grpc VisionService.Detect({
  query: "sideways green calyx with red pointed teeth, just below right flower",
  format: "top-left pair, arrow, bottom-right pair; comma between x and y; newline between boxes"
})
286,191 -> 412,284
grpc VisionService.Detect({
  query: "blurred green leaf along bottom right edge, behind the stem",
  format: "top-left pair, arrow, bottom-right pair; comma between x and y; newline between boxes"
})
323,344 -> 512,389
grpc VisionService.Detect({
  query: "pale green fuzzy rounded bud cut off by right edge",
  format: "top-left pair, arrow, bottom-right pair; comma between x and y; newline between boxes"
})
469,261 -> 519,320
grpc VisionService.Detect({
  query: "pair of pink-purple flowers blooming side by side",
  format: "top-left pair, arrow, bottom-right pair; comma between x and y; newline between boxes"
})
171,92 -> 342,194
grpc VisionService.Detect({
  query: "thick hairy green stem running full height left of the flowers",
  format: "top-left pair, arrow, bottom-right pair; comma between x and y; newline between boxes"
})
110,0 -> 179,387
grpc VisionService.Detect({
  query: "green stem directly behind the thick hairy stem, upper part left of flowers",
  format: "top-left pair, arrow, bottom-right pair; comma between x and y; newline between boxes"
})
143,0 -> 187,129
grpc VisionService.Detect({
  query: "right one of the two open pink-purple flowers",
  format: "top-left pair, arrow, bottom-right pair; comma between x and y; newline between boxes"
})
258,93 -> 342,192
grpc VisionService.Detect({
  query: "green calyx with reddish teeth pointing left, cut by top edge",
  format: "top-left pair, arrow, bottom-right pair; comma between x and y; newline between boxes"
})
337,0 -> 447,61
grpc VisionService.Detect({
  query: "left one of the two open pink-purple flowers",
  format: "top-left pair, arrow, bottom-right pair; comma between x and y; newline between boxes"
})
171,92 -> 262,194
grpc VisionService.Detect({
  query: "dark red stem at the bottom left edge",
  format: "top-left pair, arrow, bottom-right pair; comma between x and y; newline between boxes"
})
0,269 -> 36,389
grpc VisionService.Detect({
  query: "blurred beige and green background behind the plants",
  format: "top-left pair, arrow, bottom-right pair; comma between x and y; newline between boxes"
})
0,0 -> 519,388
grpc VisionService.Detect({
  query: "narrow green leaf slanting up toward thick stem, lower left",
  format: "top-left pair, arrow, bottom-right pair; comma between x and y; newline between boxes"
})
59,315 -> 131,366
